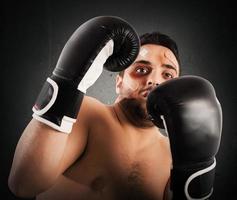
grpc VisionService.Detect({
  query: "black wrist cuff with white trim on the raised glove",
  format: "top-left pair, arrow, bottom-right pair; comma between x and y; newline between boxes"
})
33,76 -> 84,133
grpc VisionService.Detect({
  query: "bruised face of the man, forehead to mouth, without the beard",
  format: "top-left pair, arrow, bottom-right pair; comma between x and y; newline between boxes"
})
116,44 -> 179,99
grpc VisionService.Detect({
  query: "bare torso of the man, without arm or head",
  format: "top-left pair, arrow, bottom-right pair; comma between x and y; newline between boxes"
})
37,98 -> 171,200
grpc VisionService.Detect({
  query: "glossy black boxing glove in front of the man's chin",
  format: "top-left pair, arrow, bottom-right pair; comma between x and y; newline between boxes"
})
147,76 -> 222,200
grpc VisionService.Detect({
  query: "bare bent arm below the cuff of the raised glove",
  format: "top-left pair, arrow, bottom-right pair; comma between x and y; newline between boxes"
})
8,97 -> 101,197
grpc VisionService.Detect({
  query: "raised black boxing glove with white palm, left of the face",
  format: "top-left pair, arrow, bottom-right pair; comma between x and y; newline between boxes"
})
33,16 -> 140,133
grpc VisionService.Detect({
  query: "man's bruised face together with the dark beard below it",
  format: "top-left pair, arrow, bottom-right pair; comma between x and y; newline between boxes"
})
115,44 -> 179,128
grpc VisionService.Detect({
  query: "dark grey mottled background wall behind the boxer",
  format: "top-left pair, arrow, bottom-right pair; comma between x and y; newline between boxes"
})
0,0 -> 237,200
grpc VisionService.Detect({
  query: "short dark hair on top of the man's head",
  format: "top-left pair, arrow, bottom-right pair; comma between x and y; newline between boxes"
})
119,32 -> 180,76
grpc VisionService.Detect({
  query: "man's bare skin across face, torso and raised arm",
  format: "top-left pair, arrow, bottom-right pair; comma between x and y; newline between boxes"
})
9,44 -> 179,200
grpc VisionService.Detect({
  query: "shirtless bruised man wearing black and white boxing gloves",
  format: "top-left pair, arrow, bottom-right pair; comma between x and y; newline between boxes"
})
9,17 -> 221,200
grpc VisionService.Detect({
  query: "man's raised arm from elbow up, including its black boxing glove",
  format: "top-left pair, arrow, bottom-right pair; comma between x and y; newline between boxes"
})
9,16 -> 139,197
